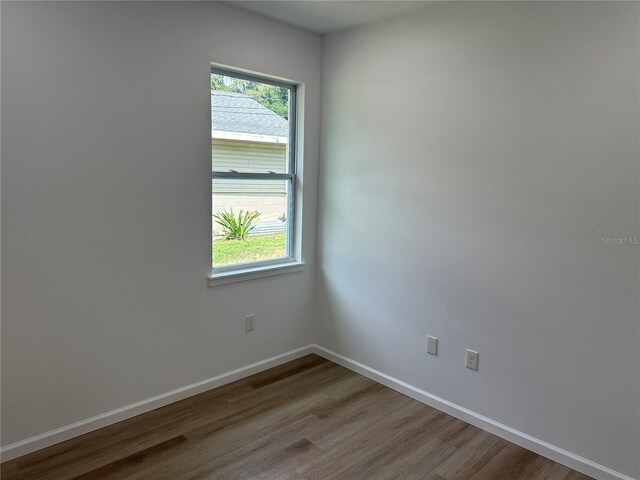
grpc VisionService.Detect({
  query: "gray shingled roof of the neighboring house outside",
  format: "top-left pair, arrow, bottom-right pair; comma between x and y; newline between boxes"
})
211,90 -> 289,137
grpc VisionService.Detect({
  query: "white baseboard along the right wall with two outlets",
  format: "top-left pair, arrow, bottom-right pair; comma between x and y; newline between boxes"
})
313,345 -> 635,480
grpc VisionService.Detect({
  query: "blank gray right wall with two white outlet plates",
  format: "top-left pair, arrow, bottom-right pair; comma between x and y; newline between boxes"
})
316,2 -> 640,477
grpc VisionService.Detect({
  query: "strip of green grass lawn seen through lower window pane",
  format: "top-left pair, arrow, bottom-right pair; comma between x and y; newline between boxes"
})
213,233 -> 287,267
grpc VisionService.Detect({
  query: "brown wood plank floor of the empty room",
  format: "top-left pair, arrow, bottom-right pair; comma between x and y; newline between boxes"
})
2,355 -> 588,480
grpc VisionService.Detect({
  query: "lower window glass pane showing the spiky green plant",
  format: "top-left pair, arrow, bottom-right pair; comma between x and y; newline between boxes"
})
212,178 -> 290,267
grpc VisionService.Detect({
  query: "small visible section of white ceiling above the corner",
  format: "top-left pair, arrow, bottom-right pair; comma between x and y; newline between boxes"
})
228,0 -> 428,34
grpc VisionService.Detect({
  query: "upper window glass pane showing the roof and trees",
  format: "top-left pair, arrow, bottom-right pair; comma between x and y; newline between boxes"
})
211,73 -> 290,173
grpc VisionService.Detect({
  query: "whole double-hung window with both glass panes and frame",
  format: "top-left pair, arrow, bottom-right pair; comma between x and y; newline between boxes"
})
211,67 -> 296,278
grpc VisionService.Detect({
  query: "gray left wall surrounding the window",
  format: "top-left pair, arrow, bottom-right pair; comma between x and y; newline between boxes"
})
2,2 -> 321,445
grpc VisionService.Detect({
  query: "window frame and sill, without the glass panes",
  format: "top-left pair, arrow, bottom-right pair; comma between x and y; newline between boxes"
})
209,64 -> 304,287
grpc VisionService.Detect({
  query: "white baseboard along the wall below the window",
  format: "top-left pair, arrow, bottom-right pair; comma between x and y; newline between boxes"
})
0,345 -> 313,462
